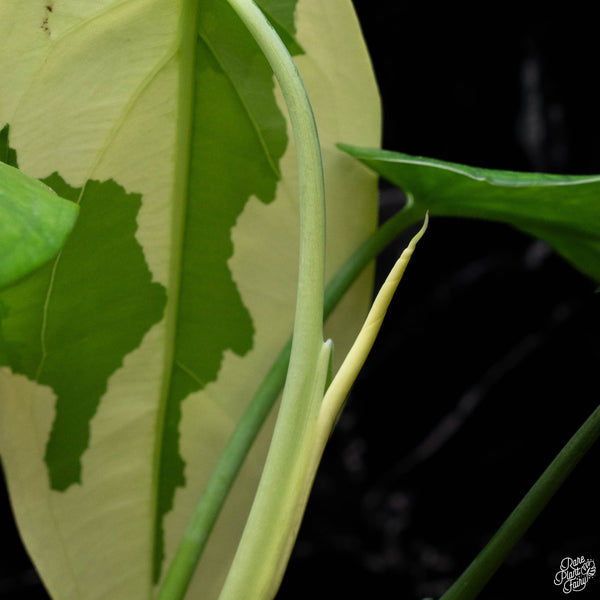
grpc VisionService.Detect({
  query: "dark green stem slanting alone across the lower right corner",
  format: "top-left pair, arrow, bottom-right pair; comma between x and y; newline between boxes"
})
440,406 -> 600,600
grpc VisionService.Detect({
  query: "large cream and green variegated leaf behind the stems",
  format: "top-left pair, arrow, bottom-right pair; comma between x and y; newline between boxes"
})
0,0 -> 379,600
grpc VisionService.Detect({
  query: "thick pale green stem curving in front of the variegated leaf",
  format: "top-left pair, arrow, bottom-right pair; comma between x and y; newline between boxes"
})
220,0 -> 329,600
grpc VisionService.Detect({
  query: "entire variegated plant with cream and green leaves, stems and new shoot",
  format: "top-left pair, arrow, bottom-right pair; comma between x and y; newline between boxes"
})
0,0 -> 600,599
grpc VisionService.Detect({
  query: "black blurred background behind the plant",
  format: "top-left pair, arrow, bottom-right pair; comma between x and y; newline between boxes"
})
0,5 -> 600,600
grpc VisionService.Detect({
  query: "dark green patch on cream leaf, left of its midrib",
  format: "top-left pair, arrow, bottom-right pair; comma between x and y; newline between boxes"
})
0,136 -> 166,490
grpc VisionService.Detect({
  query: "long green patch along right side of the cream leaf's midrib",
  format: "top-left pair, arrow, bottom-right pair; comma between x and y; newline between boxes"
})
154,0 -> 301,581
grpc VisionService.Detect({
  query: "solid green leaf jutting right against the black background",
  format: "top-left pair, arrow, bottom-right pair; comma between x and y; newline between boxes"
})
340,145 -> 600,281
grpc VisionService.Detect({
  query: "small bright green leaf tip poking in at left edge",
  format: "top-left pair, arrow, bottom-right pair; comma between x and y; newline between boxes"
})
0,127 -> 78,288
